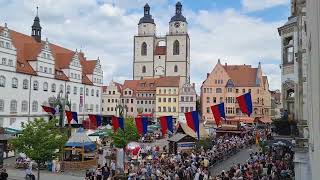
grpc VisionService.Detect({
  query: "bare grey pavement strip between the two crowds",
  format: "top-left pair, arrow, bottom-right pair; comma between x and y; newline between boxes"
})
210,145 -> 258,175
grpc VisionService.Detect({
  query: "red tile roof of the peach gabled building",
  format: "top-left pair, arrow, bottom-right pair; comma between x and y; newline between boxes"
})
223,65 -> 259,87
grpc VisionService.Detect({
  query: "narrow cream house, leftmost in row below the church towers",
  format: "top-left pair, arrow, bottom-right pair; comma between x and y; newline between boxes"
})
101,81 -> 122,117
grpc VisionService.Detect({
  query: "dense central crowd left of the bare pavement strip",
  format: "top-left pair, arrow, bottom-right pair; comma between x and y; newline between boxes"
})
124,134 -> 254,180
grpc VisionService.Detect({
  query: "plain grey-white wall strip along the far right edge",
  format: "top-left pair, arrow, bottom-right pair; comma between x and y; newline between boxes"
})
306,0 -> 320,180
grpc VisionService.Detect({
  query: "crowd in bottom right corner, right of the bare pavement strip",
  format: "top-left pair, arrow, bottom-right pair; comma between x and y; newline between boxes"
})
214,145 -> 294,180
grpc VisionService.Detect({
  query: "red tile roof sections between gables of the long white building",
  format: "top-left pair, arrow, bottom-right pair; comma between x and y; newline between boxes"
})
0,26 -> 97,84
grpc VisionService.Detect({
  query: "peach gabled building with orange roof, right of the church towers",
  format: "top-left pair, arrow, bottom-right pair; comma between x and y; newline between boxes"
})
200,60 -> 271,122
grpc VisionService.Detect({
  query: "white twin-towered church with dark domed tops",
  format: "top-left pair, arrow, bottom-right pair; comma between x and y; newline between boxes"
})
133,2 -> 190,84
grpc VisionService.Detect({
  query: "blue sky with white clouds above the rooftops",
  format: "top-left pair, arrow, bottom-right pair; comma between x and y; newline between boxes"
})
0,0 -> 290,92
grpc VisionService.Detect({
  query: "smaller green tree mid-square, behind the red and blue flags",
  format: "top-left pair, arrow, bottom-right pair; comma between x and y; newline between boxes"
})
110,117 -> 140,148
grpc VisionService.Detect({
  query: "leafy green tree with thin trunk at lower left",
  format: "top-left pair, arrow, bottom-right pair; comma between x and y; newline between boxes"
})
12,118 -> 67,180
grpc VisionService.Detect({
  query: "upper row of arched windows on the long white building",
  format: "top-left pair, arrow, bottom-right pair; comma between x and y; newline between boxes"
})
0,76 -> 100,97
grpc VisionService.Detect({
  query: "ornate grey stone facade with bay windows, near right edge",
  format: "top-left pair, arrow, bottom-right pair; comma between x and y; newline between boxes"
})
278,0 -> 310,179
